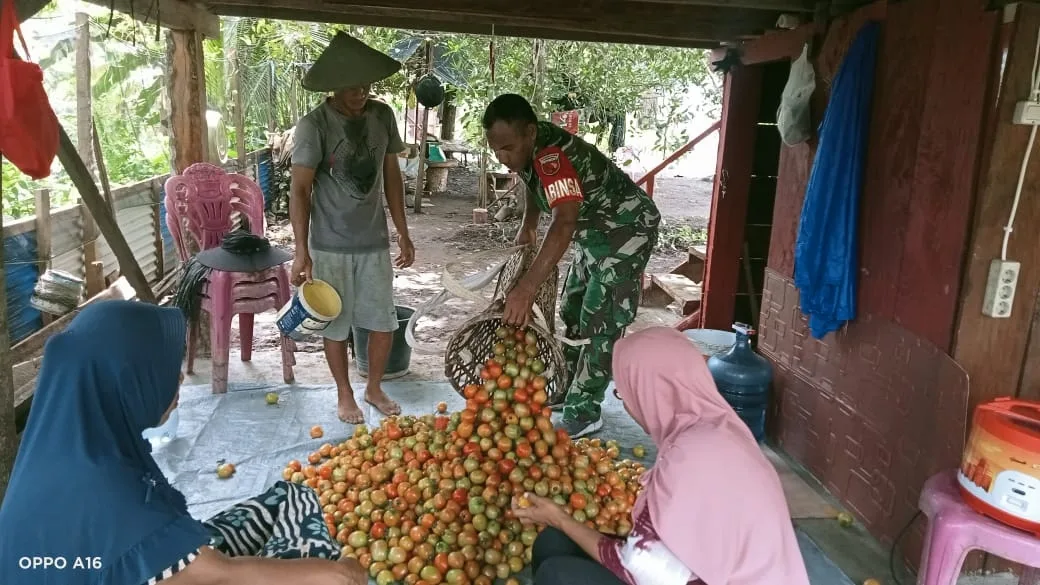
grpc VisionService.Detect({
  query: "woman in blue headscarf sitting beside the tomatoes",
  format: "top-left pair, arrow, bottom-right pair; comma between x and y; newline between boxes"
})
0,301 -> 367,585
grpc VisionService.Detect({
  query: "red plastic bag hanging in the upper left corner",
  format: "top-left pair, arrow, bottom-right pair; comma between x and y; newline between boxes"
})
0,0 -> 58,179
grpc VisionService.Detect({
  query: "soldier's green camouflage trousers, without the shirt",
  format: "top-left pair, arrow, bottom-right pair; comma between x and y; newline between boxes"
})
560,232 -> 657,421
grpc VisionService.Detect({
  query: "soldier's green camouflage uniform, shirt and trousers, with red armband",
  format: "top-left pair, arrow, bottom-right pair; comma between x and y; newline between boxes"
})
521,122 -> 660,421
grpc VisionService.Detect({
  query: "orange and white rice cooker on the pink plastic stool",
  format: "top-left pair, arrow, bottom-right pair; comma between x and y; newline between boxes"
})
957,398 -> 1040,535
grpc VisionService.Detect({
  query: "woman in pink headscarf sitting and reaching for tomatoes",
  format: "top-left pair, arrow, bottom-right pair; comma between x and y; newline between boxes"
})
514,327 -> 809,585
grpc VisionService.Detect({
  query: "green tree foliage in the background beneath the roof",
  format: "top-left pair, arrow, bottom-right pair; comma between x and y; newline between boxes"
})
2,4 -> 718,218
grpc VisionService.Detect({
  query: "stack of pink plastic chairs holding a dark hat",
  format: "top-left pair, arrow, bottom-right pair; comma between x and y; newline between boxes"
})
165,162 -> 296,393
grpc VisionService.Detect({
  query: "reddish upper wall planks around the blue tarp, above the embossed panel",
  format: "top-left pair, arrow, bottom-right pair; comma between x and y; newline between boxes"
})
759,0 -> 999,349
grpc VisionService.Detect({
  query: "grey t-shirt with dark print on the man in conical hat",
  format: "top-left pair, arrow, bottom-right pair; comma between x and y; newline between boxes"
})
292,99 -> 405,253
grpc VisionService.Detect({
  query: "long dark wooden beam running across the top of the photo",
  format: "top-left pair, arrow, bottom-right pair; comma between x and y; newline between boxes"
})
211,0 -> 775,45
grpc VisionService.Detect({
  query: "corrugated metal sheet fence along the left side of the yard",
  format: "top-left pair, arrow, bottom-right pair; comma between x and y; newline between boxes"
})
3,150 -> 274,345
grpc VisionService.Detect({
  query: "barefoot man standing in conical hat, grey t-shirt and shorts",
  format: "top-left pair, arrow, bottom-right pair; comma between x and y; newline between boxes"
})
289,32 -> 415,424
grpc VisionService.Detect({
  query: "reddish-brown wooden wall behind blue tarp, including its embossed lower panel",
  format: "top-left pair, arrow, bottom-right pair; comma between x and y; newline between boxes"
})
736,0 -> 1002,554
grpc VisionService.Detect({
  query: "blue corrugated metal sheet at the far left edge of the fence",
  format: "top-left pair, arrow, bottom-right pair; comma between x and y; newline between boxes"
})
3,231 -> 43,344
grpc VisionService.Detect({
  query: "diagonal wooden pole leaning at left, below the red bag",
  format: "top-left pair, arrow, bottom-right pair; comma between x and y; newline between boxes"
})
58,125 -> 155,303
